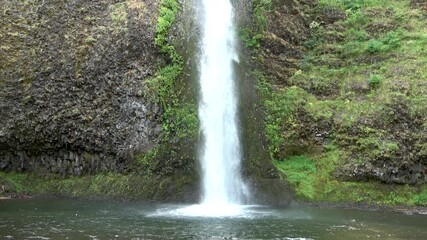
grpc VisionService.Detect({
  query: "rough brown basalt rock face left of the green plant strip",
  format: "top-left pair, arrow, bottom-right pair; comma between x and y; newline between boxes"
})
0,0 -> 161,175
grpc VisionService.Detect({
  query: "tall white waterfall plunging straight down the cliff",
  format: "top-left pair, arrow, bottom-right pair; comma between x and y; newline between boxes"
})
199,0 -> 248,205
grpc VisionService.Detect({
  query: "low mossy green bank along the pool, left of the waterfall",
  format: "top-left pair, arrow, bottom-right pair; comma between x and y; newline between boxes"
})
0,172 -> 194,201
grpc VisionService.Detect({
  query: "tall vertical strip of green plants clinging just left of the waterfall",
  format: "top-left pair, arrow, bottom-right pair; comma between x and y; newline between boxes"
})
146,0 -> 198,140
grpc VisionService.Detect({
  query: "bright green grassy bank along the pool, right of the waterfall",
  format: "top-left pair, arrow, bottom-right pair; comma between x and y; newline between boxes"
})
274,153 -> 427,206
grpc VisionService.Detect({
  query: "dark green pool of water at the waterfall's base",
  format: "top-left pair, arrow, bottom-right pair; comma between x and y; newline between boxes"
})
0,199 -> 427,240
